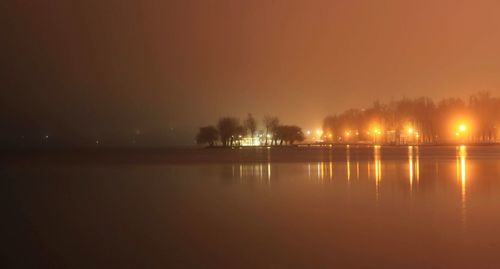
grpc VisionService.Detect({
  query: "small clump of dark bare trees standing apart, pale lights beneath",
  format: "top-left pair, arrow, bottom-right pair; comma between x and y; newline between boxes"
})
196,114 -> 305,147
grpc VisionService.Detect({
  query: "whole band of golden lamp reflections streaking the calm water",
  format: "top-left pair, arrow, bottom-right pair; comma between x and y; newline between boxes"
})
219,146 -> 484,234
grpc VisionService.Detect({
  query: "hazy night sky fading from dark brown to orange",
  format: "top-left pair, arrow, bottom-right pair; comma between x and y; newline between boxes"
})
0,0 -> 500,145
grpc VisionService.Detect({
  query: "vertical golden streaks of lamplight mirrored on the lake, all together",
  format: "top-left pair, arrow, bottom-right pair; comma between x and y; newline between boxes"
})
221,146 -> 474,219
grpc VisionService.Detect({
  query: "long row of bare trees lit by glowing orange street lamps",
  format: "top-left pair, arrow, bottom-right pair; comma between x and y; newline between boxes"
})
323,92 -> 500,143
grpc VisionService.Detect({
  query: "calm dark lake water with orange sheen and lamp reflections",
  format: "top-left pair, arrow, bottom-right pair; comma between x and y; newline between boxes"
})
0,147 -> 500,268
